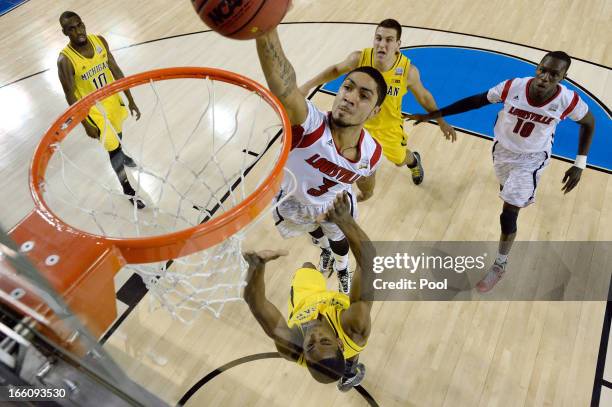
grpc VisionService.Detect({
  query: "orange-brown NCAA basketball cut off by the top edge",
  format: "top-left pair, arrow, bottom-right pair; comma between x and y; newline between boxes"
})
191,0 -> 290,40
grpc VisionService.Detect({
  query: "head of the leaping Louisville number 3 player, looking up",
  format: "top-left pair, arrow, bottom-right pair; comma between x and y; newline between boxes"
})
332,66 -> 387,127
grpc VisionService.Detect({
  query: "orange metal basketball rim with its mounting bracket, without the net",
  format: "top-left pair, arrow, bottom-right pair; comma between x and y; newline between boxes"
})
0,67 -> 291,342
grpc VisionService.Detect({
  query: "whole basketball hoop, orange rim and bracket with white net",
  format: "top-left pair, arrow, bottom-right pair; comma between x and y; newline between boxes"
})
0,67 -> 291,335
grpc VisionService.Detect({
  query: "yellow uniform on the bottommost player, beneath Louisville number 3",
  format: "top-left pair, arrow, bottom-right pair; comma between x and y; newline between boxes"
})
287,268 -> 366,366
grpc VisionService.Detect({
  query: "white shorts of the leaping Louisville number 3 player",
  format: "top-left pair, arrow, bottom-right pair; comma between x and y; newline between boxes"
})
272,191 -> 357,241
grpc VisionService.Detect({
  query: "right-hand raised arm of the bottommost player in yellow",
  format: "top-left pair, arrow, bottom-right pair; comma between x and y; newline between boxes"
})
318,192 -> 376,340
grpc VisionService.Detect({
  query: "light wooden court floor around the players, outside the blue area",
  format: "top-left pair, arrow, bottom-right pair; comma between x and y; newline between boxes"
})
0,0 -> 612,407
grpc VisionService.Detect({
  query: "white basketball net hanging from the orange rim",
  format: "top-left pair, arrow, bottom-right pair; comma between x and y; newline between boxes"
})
43,75 -> 292,322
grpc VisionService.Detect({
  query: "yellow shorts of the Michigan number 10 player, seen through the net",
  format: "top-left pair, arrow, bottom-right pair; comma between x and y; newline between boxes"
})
87,96 -> 128,151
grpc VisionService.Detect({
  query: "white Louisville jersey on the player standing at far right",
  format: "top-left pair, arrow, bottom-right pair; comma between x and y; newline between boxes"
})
487,78 -> 589,153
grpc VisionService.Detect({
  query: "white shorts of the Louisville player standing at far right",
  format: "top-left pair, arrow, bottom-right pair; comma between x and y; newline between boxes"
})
493,141 -> 550,208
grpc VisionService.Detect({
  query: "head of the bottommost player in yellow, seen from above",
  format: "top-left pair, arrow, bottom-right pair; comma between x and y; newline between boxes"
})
302,320 -> 345,383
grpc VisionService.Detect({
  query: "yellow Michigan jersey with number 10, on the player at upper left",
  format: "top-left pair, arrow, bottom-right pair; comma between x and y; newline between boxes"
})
61,34 -> 124,109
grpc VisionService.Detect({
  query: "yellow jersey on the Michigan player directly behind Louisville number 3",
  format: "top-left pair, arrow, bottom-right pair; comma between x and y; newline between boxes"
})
359,48 -> 410,133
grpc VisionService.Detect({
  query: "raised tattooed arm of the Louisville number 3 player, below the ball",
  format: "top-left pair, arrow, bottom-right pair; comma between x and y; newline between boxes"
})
255,28 -> 308,125
